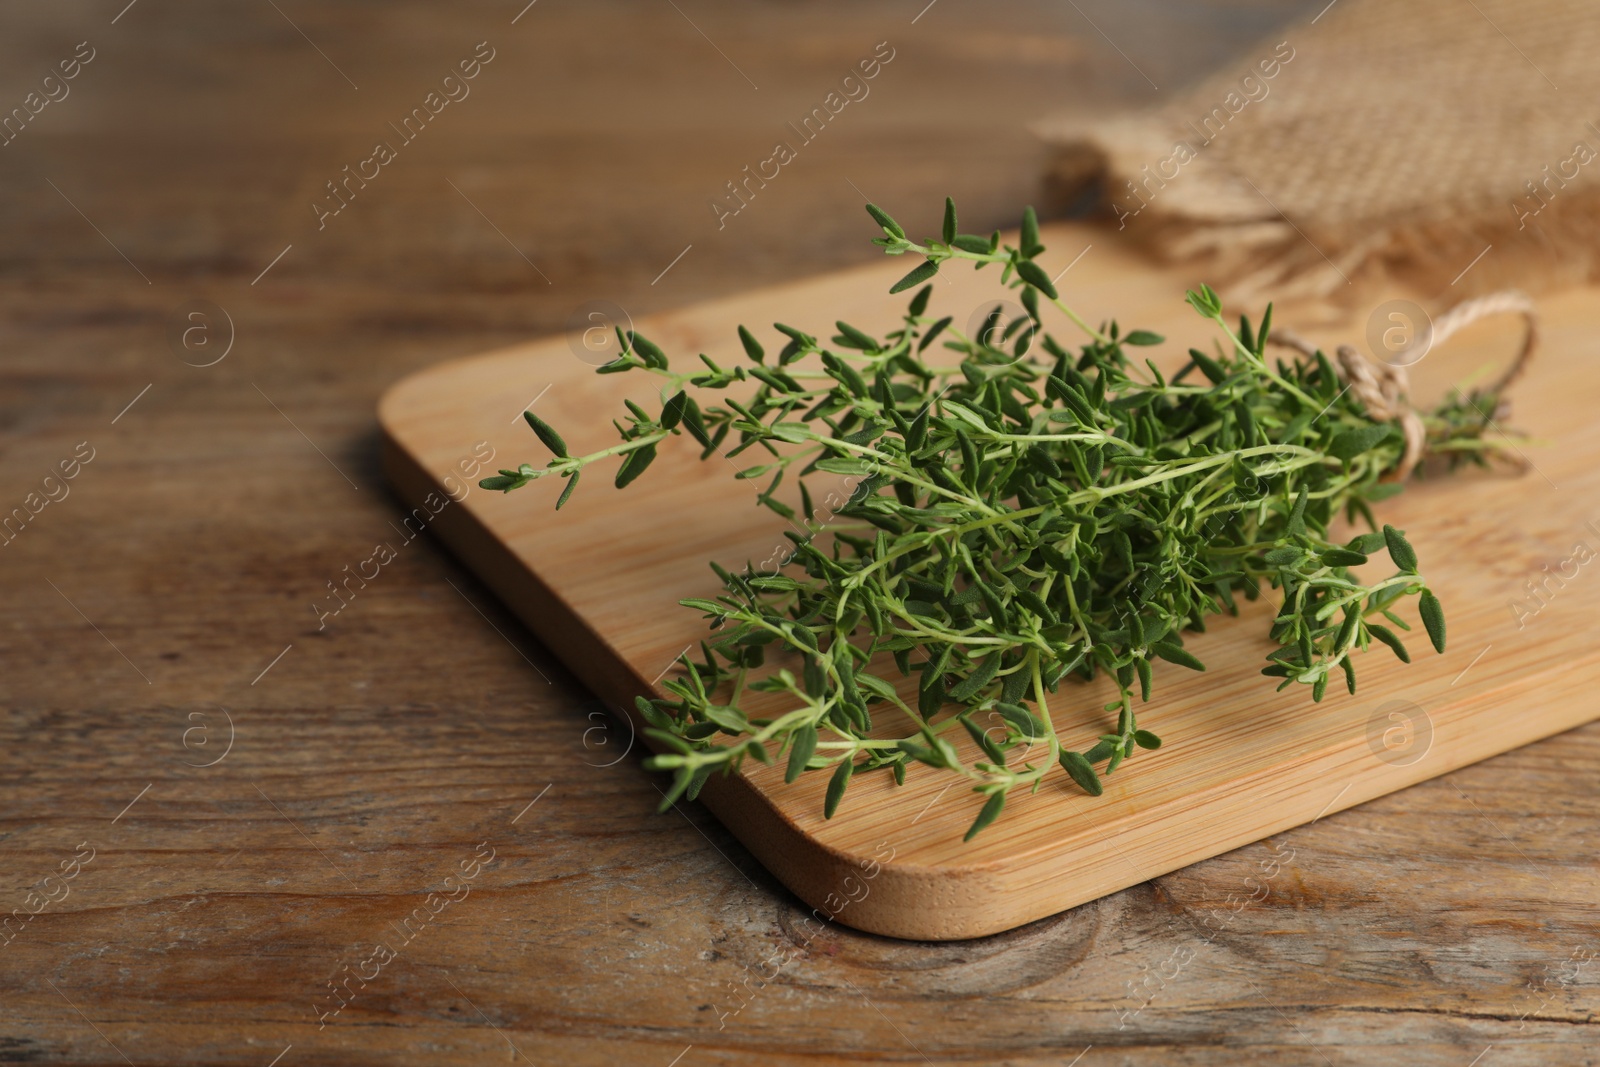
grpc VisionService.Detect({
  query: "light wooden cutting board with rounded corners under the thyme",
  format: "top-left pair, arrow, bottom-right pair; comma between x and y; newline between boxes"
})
379,226 -> 1600,939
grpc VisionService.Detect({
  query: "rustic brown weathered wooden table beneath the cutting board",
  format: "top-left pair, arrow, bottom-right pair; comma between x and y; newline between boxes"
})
0,0 -> 1600,1067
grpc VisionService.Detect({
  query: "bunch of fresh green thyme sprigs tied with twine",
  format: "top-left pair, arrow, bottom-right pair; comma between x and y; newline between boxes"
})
482,202 -> 1498,838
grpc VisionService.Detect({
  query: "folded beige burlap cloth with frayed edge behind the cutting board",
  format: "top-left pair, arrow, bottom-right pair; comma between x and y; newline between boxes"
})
1040,0 -> 1600,302
